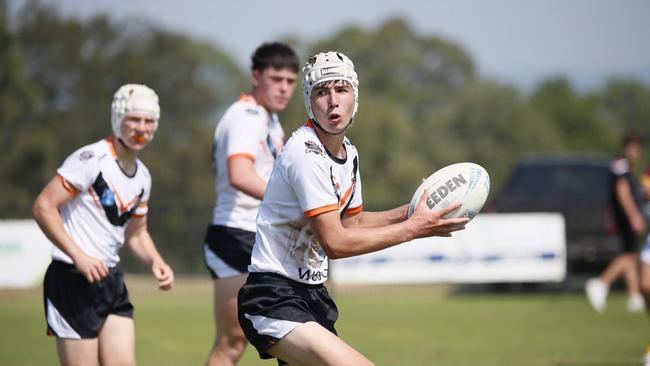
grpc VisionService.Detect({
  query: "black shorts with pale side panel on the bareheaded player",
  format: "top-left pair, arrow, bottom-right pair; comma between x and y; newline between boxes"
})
203,225 -> 255,279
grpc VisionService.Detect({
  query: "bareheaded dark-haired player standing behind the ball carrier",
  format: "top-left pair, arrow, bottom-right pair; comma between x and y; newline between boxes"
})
204,43 -> 298,365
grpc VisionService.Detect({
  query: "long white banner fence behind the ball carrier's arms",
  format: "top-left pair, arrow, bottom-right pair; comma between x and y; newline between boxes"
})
330,213 -> 566,284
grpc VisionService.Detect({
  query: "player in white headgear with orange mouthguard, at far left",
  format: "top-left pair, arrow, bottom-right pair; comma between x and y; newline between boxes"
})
32,84 -> 174,365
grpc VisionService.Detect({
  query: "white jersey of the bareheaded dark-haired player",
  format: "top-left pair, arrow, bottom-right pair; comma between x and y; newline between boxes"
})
212,94 -> 284,232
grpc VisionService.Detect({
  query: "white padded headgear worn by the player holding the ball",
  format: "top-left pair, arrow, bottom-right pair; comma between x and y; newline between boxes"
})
302,51 -> 359,122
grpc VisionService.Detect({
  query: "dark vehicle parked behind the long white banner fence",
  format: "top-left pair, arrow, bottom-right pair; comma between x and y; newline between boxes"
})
488,156 -> 620,273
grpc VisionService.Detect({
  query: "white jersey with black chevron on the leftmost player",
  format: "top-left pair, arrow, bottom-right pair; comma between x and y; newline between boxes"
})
52,137 -> 151,267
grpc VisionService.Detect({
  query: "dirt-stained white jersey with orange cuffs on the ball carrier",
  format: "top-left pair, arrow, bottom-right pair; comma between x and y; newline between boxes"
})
248,121 -> 362,284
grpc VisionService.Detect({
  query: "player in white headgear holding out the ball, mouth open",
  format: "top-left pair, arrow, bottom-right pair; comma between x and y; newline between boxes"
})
238,52 -> 468,365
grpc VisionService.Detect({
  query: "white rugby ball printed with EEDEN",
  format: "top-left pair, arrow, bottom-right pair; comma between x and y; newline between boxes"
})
408,163 -> 490,220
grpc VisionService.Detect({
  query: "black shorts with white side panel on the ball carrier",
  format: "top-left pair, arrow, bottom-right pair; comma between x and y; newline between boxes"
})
237,272 -> 339,359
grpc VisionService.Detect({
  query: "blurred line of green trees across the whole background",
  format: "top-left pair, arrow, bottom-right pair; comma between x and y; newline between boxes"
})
0,0 -> 650,272
